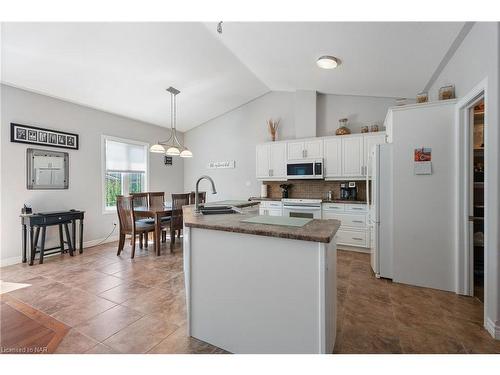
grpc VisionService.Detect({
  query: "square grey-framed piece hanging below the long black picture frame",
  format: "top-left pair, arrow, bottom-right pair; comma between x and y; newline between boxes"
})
26,148 -> 69,190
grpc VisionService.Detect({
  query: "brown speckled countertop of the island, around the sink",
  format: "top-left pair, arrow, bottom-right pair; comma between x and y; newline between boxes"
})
182,205 -> 340,243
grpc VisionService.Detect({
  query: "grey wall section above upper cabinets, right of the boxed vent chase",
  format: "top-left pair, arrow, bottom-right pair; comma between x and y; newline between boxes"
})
316,94 -> 396,137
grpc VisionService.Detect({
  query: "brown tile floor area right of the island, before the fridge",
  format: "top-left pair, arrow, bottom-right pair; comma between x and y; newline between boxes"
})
334,251 -> 500,353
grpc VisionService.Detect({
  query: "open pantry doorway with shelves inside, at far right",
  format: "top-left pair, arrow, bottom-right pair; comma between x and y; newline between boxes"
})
468,97 -> 485,303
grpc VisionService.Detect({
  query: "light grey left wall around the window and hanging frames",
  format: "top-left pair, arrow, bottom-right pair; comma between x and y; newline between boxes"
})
0,85 -> 183,265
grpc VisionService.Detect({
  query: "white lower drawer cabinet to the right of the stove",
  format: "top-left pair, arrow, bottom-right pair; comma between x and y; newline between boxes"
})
322,203 -> 370,248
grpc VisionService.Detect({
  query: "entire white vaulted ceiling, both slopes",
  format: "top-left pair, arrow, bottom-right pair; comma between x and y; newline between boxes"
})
2,22 -> 463,131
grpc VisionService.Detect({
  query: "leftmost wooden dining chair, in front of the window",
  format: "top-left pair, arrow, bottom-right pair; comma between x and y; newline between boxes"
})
116,195 -> 155,258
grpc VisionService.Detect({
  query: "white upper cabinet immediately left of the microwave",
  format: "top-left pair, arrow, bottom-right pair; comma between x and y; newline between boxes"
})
255,142 -> 286,180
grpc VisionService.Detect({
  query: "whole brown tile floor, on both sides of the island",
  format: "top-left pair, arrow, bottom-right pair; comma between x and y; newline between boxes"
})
0,241 -> 500,353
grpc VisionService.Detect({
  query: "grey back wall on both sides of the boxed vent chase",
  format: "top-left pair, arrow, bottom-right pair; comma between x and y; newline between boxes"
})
184,91 -> 395,200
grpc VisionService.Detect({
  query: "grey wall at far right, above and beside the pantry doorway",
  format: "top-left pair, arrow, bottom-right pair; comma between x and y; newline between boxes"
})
430,22 -> 500,339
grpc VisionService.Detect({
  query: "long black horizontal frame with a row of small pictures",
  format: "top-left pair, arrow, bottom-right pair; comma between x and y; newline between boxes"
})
10,122 -> 79,150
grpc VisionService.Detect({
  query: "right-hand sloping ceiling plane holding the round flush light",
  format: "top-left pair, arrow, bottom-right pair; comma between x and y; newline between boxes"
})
207,22 -> 463,98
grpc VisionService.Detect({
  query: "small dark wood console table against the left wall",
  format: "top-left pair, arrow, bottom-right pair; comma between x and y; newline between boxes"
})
21,210 -> 85,266
